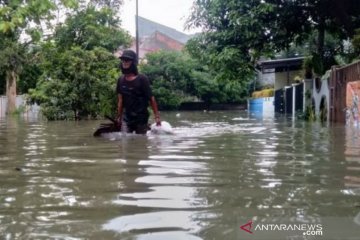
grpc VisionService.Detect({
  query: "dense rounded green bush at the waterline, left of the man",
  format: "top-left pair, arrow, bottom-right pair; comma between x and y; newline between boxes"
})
30,47 -> 118,120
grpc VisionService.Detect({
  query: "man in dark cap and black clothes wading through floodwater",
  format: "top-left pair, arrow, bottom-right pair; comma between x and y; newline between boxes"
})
116,50 -> 161,134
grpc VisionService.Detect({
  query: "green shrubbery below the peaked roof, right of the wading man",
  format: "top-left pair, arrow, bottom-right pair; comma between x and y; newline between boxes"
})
141,51 -> 242,109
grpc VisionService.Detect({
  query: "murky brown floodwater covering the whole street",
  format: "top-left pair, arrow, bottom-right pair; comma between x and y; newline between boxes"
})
0,111 -> 360,240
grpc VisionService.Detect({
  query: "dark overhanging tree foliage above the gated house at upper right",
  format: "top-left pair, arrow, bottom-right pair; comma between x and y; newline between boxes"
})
188,0 -> 360,82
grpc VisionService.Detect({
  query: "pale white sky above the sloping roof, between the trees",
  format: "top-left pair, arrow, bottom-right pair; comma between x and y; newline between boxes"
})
120,0 -> 199,36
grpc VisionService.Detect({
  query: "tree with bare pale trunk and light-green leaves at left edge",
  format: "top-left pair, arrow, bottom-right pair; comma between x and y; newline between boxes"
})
0,0 -> 77,113
